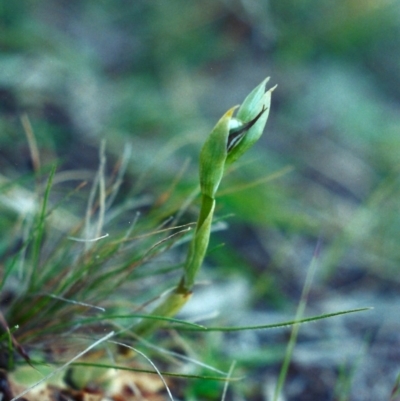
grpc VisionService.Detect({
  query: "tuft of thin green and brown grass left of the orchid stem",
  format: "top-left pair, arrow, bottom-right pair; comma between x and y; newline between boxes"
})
0,133 -> 198,396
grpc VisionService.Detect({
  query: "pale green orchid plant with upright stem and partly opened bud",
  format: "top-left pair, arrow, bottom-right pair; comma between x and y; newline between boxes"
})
135,78 -> 276,336
